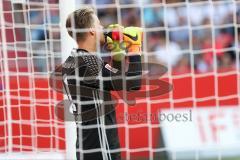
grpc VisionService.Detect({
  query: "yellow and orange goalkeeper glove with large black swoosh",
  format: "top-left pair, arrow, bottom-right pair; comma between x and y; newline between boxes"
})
123,27 -> 143,55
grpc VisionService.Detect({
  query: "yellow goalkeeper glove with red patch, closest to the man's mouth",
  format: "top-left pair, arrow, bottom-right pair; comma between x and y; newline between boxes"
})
105,24 -> 126,61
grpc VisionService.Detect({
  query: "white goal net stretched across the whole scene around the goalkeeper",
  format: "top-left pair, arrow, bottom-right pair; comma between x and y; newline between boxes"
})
0,0 -> 240,160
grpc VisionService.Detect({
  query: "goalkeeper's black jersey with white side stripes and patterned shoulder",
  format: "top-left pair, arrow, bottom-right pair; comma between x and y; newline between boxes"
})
62,49 -> 142,160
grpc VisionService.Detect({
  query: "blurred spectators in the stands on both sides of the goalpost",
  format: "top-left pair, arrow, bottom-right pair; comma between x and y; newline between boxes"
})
3,0 -> 240,74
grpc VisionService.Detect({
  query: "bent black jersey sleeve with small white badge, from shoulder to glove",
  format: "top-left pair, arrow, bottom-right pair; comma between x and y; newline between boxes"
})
75,55 -> 142,91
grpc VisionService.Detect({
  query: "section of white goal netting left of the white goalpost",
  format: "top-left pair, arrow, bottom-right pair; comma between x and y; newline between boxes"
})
0,0 -> 65,159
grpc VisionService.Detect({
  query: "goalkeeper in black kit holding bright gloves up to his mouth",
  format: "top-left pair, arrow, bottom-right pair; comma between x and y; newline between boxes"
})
62,8 -> 142,160
